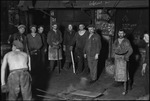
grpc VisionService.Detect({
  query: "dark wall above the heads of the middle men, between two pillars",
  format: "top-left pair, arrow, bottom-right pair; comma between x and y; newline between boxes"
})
56,9 -> 92,32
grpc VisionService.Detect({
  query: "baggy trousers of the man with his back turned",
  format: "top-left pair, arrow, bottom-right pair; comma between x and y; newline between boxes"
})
8,70 -> 32,101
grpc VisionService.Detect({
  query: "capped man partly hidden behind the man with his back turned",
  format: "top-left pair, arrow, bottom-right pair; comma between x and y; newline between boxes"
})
8,25 -> 28,53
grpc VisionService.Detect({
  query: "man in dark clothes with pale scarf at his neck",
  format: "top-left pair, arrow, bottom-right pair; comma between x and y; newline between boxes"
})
70,24 -> 89,74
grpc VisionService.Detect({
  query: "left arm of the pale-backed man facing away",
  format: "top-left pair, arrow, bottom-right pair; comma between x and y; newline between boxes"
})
1,54 -> 8,85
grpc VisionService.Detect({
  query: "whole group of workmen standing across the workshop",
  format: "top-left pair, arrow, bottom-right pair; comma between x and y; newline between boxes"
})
1,23 -> 149,100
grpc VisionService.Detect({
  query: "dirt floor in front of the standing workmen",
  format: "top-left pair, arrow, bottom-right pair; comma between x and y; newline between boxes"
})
33,63 -> 147,101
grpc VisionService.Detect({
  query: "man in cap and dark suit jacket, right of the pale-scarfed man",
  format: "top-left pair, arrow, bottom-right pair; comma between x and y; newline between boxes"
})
84,25 -> 102,82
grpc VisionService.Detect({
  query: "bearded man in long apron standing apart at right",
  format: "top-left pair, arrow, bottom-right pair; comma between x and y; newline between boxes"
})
112,29 -> 133,95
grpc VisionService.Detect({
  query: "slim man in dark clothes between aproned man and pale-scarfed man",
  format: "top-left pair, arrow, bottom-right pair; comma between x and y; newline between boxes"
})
63,24 -> 75,69
